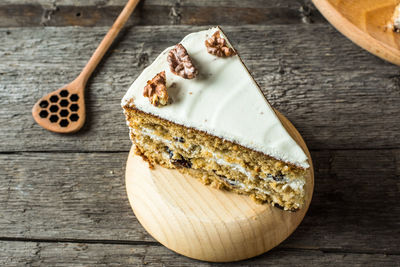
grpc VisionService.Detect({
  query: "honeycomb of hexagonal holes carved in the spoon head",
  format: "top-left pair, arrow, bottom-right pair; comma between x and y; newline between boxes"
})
39,90 -> 80,127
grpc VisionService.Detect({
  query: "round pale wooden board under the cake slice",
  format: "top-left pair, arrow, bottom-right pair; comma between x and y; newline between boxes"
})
125,112 -> 314,262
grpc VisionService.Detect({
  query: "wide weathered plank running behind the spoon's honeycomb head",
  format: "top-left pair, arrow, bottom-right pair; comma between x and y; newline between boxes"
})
0,25 -> 400,151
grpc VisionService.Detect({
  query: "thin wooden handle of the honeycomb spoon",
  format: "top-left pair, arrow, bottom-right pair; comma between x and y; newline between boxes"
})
75,0 -> 140,86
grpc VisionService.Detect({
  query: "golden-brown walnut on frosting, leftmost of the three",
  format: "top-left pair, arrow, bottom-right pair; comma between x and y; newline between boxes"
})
143,71 -> 168,107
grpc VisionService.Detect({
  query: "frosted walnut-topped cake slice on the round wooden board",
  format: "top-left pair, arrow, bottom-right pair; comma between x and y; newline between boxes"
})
122,27 -> 309,210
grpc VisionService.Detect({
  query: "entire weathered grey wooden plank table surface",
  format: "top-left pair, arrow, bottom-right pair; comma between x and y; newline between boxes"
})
0,0 -> 400,266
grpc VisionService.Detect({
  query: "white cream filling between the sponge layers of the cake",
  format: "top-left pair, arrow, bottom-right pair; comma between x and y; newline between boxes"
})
130,127 -> 305,195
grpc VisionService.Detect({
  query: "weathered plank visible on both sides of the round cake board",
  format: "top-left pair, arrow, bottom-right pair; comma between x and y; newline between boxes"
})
0,150 -> 400,254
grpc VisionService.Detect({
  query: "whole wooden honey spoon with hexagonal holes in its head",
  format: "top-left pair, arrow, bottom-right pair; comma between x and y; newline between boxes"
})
32,0 -> 140,133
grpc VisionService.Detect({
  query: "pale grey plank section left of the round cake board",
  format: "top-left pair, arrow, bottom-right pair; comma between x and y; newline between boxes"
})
0,153 -> 153,241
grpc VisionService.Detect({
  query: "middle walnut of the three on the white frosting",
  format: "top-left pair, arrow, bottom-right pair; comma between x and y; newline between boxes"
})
167,44 -> 198,79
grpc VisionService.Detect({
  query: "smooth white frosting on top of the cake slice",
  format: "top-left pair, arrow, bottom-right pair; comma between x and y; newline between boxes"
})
121,28 -> 309,168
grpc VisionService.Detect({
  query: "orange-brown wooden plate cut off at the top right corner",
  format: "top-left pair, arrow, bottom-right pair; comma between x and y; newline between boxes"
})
313,0 -> 400,65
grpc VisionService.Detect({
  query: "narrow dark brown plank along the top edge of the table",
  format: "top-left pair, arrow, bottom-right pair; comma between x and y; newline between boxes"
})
0,0 -> 325,27
